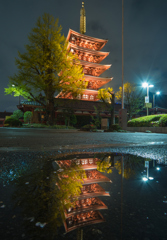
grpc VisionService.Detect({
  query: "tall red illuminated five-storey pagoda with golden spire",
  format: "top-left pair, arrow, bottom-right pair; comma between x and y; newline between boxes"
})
56,2 -> 112,101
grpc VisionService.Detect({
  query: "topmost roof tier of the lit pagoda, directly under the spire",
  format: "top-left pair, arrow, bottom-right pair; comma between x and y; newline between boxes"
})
67,29 -> 108,49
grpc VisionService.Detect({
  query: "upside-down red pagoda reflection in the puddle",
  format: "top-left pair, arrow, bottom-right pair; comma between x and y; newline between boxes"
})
56,157 -> 111,232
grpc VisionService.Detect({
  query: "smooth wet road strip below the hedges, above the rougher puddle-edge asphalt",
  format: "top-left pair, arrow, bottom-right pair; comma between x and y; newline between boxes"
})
0,128 -> 167,150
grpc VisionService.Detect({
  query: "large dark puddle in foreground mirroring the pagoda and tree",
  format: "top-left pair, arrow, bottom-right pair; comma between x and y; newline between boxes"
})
0,153 -> 167,240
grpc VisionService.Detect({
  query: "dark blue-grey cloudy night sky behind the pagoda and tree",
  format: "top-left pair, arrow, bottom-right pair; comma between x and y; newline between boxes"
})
0,0 -> 167,112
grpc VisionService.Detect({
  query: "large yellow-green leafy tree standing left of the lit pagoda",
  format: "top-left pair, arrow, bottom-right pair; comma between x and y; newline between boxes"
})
5,13 -> 86,125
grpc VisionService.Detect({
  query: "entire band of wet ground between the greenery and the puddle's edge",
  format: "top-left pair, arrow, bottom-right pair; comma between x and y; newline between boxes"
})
0,128 -> 167,160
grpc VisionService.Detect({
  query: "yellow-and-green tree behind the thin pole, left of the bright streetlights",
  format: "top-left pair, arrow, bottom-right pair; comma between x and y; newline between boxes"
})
115,82 -> 144,119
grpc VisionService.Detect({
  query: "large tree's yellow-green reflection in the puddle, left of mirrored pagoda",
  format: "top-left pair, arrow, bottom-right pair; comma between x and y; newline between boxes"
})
13,158 -> 84,239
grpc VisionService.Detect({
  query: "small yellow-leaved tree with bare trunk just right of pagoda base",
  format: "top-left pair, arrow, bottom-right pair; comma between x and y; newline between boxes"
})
98,88 -> 115,128
